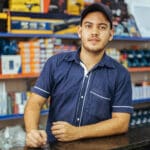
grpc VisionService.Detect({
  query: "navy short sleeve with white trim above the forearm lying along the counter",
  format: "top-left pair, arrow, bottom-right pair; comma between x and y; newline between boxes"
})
112,71 -> 133,113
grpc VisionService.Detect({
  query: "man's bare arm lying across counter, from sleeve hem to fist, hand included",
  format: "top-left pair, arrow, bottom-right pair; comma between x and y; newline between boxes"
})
51,113 -> 130,142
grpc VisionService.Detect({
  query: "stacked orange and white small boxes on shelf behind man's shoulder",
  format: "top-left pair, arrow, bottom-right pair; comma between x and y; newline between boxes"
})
19,38 -> 77,74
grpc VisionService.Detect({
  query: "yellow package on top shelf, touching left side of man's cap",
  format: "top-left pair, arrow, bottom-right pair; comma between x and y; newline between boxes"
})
67,0 -> 84,15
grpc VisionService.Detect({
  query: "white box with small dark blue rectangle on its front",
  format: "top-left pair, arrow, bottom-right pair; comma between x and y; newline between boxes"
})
1,55 -> 21,74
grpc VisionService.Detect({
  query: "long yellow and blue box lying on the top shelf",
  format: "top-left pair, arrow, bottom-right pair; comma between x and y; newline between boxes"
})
8,16 -> 63,34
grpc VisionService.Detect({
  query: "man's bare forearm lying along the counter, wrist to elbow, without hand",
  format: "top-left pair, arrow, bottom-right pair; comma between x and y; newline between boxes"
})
77,113 -> 129,139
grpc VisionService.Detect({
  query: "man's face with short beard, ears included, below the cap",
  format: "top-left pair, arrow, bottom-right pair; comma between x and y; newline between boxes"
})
78,12 -> 113,53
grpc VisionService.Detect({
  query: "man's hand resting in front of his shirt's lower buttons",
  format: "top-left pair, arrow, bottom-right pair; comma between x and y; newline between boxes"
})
51,121 -> 80,142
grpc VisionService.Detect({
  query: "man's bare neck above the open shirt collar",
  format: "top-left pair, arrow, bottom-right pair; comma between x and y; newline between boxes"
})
80,48 -> 104,70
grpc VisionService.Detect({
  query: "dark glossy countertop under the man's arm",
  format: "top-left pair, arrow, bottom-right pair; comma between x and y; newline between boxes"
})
14,126 -> 150,150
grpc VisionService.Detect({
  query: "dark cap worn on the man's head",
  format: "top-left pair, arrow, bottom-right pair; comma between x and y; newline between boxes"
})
80,3 -> 113,28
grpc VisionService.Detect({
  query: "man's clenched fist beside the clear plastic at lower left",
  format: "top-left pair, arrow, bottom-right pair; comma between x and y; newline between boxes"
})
26,130 -> 47,147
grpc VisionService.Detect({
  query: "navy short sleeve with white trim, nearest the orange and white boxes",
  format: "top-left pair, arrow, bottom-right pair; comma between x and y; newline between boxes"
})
31,58 -> 54,98
